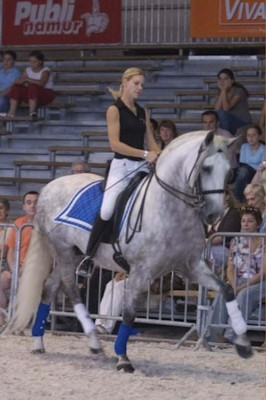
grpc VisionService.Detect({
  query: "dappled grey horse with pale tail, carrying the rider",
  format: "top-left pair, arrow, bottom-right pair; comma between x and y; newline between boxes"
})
3,131 -> 251,372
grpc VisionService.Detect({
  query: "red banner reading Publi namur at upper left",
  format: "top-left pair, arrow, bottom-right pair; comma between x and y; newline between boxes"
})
3,0 -> 121,45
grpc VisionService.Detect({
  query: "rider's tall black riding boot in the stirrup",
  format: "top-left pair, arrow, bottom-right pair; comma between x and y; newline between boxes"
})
76,215 -> 108,276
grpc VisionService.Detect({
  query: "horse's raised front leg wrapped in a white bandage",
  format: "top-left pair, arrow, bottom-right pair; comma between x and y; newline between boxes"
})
193,260 -> 252,358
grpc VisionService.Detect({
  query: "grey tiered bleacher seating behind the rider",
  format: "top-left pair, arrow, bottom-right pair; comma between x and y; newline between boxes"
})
0,50 -> 264,217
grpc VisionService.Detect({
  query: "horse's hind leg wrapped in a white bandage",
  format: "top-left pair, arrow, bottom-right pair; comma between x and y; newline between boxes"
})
60,255 -> 102,353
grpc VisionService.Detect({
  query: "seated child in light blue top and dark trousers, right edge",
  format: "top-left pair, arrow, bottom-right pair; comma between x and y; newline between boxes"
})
234,125 -> 265,202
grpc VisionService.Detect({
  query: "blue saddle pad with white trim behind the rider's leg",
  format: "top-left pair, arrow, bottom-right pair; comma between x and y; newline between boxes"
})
54,180 -> 103,231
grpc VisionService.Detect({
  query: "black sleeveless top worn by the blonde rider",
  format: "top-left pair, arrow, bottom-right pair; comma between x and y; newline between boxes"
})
114,99 -> 146,161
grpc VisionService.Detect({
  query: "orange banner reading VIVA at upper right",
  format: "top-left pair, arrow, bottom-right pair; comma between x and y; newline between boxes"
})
190,0 -> 266,38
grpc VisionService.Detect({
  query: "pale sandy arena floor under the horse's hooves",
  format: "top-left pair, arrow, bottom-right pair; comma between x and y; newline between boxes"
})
0,333 -> 266,400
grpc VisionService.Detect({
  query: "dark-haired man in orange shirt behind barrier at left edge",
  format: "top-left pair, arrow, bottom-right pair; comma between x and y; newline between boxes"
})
0,191 -> 39,327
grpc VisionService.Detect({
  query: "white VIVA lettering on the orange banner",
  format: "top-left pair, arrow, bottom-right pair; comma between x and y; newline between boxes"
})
219,0 -> 266,25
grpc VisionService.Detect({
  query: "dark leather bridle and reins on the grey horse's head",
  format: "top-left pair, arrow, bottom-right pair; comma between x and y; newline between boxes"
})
154,150 -> 225,209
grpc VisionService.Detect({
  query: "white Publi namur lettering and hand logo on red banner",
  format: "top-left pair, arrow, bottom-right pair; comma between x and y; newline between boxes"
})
14,0 -> 109,37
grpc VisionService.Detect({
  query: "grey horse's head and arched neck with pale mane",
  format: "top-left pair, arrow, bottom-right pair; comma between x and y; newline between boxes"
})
156,131 -> 239,224
